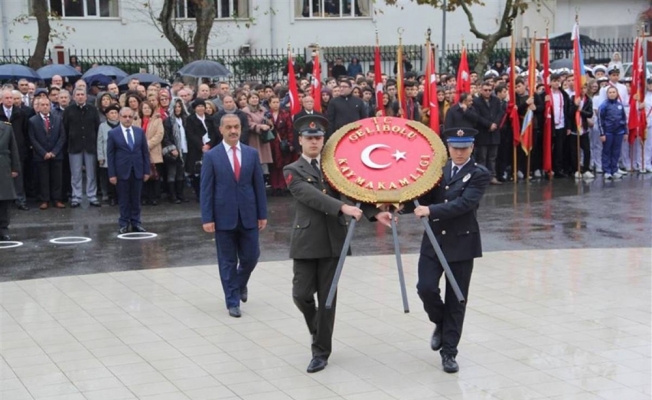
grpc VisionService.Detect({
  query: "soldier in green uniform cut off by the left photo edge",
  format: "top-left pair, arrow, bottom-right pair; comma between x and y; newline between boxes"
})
0,122 -> 20,242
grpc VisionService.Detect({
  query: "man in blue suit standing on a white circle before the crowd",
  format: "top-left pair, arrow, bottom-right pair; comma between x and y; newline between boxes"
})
106,107 -> 150,234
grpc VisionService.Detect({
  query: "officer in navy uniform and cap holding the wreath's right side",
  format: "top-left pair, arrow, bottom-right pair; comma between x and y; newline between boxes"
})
402,128 -> 491,373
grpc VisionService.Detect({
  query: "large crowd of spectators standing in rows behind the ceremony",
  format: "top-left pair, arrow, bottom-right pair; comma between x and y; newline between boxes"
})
0,48 -> 652,239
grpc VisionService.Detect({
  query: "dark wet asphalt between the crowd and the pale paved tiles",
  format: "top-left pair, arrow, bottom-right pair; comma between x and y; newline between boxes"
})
0,174 -> 652,281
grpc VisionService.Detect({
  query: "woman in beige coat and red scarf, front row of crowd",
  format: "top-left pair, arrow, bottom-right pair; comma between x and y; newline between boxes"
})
140,101 -> 163,206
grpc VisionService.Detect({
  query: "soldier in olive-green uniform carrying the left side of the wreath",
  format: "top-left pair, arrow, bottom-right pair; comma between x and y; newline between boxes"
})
283,115 -> 392,373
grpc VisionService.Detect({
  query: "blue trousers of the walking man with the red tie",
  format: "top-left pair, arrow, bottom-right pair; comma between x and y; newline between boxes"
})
215,222 -> 260,308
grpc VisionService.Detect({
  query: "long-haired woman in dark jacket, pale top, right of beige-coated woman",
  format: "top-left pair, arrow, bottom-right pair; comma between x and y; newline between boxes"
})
161,99 -> 188,204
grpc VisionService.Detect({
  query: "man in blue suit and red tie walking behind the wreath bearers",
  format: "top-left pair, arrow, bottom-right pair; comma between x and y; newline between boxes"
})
200,114 -> 267,318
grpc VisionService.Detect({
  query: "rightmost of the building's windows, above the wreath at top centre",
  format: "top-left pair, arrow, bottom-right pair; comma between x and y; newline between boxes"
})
294,0 -> 371,18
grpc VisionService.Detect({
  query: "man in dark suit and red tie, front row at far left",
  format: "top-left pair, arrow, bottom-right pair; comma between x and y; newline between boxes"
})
29,99 -> 66,210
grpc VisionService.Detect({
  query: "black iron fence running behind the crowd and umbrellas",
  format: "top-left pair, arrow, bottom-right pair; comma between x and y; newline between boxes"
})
0,38 -> 634,84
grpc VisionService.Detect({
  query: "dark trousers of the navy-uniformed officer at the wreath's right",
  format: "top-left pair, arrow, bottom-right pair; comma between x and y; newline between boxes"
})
417,254 -> 473,356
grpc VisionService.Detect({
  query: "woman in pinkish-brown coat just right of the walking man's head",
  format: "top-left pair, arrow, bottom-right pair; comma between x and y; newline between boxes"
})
243,92 -> 274,179
